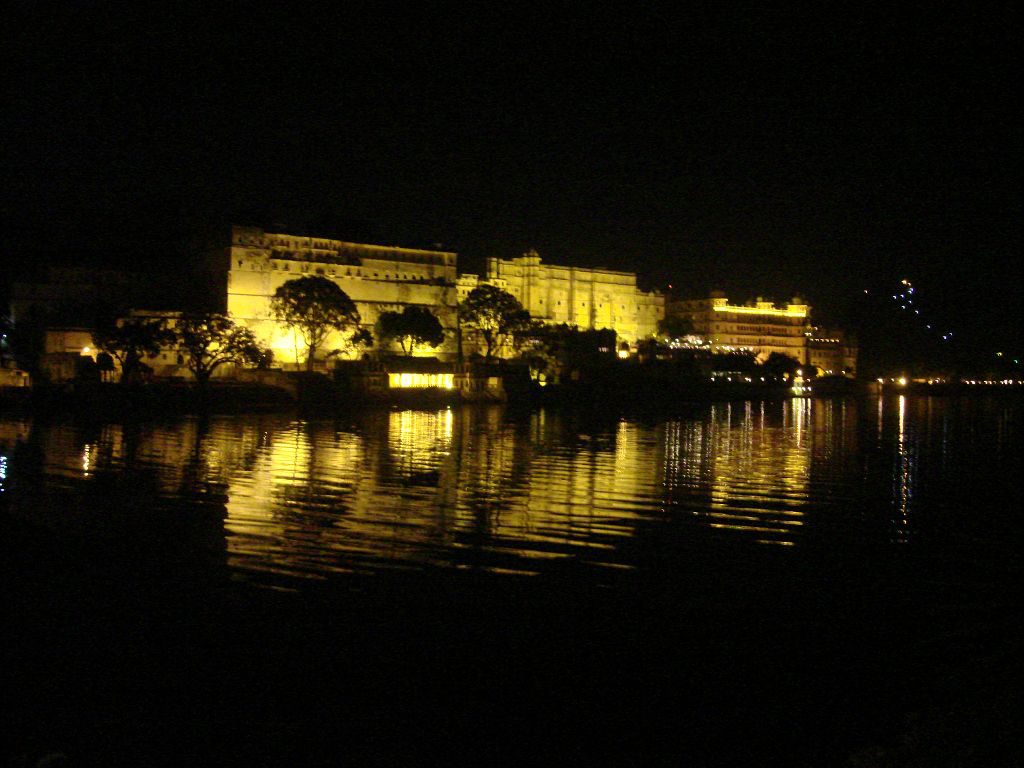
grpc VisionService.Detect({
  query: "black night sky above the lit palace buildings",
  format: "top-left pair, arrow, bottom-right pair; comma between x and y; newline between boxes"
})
0,3 -> 1022,348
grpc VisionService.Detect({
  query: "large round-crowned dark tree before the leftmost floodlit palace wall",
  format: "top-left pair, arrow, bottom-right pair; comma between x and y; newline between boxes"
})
270,276 -> 359,371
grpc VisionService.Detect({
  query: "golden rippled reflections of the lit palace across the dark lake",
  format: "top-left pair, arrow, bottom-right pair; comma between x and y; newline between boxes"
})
0,396 -> 1019,582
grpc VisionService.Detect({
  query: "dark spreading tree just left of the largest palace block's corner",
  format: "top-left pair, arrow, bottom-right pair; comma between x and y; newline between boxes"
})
175,312 -> 264,385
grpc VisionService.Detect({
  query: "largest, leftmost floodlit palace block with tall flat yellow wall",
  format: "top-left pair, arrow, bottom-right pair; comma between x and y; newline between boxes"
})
222,226 -> 457,362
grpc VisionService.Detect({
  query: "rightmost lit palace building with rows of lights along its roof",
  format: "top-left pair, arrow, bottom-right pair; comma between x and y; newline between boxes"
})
671,291 -> 857,376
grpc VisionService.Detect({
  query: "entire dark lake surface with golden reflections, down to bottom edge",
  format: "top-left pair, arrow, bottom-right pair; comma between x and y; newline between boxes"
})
0,396 -> 1021,766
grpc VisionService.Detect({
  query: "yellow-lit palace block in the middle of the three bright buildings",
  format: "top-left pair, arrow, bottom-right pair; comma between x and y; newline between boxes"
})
459,251 -> 665,342
